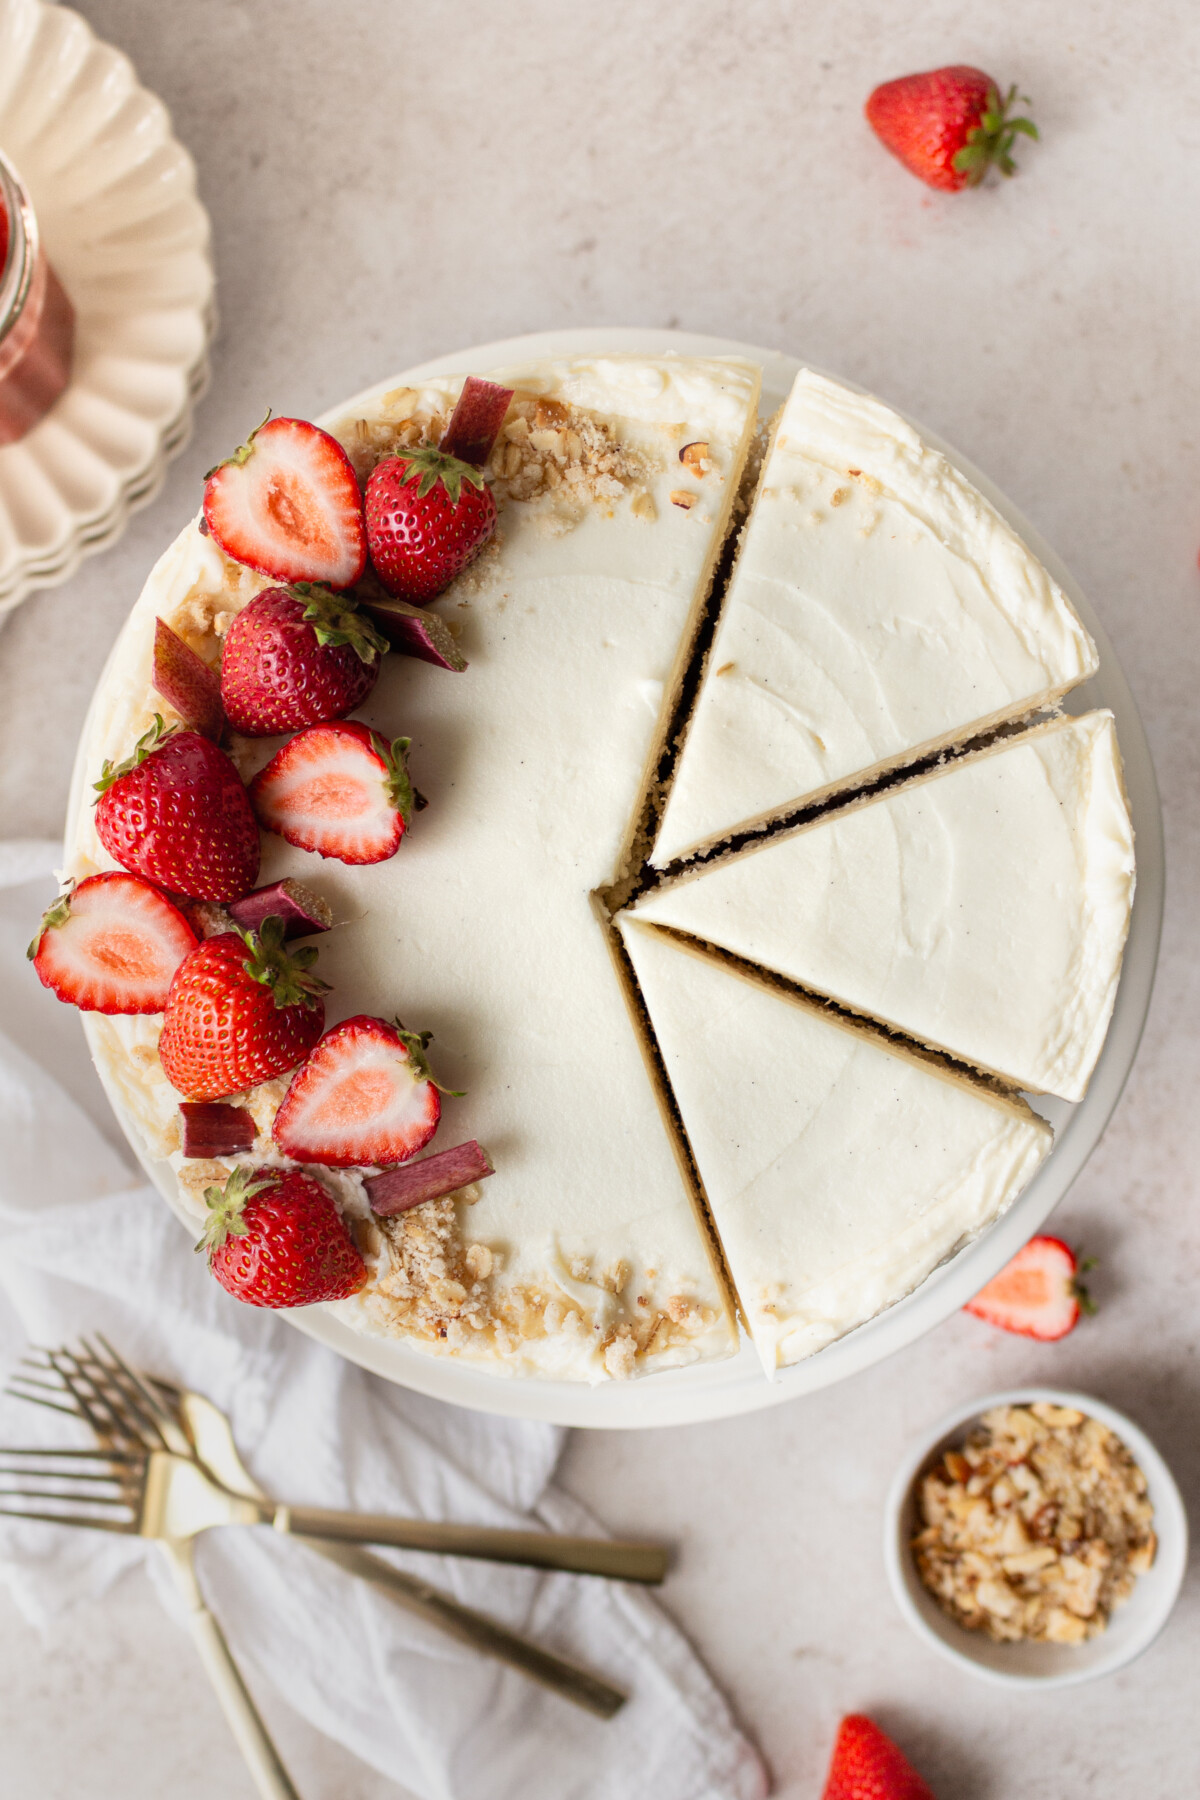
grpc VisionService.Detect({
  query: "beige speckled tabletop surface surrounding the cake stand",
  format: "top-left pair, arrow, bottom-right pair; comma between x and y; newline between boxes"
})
0,0 -> 1200,1800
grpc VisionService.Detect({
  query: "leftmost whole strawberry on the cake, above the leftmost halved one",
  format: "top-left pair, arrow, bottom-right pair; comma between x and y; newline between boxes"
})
95,713 -> 259,900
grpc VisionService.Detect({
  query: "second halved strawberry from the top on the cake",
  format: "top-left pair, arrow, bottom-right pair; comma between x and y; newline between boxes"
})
250,720 -> 416,862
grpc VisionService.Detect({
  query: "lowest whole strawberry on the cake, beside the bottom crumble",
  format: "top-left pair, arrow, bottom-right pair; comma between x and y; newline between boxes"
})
196,1165 -> 367,1307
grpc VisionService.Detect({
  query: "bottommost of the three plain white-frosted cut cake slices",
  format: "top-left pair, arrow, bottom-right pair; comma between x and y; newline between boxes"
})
621,914 -> 1052,1373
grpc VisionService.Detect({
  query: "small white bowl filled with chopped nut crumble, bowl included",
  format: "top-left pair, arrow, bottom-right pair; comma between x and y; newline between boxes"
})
883,1388 -> 1187,1688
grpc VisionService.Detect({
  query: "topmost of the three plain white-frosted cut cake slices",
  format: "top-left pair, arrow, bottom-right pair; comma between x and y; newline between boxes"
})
653,369 -> 1097,868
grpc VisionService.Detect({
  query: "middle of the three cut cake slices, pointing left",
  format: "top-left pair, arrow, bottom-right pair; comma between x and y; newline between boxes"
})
635,713 -> 1133,1100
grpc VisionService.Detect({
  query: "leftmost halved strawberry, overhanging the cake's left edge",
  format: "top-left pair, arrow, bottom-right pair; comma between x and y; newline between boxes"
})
29,873 -> 196,1013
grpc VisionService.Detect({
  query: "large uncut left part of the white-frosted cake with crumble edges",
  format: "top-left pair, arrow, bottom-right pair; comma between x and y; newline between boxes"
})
76,356 -> 757,1381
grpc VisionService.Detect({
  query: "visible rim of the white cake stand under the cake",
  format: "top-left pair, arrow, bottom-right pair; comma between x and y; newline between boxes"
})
67,329 -> 1164,1429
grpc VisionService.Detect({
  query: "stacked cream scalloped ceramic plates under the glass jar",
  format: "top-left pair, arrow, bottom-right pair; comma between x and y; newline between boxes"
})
0,0 -> 212,616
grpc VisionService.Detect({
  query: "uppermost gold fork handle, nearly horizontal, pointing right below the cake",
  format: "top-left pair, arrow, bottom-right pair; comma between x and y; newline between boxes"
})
263,1503 -> 667,1584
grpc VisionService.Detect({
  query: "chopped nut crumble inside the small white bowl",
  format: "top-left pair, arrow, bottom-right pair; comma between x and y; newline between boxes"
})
912,1400 -> 1157,1643
